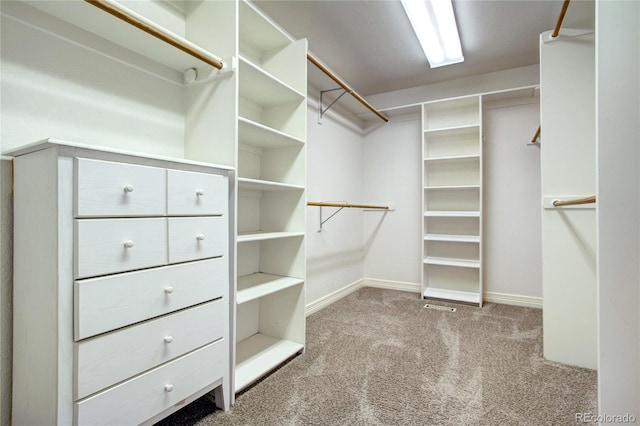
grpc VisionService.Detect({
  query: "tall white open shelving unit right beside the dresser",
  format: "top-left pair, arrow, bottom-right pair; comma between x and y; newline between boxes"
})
234,1 -> 307,392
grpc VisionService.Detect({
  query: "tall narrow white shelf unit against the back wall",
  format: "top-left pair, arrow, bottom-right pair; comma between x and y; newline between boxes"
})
422,96 -> 482,306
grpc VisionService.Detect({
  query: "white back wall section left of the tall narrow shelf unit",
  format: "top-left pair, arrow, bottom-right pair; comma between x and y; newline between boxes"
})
362,116 -> 422,292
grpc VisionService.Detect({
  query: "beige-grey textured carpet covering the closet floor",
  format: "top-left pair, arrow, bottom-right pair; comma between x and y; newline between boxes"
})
161,288 -> 597,425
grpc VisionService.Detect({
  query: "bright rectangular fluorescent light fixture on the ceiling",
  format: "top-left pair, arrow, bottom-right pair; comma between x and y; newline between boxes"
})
400,0 -> 464,68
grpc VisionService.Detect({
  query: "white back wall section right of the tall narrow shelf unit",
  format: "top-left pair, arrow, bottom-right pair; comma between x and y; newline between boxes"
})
482,98 -> 542,303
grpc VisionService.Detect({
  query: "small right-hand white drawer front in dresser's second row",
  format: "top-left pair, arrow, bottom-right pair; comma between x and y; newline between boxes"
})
169,216 -> 229,263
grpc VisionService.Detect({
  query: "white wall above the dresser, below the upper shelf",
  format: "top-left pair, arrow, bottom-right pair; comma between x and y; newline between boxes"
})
1,2 -> 184,157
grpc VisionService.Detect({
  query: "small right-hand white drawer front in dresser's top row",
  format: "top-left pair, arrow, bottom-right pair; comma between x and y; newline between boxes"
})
167,170 -> 228,216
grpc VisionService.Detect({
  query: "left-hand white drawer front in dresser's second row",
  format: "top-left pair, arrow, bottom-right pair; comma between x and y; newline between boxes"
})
75,218 -> 167,278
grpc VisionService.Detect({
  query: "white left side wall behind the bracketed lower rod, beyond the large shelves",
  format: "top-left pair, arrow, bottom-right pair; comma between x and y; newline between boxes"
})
306,102 -> 364,304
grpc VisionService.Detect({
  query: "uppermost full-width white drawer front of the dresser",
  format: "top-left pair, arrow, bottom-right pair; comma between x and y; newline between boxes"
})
74,257 -> 229,341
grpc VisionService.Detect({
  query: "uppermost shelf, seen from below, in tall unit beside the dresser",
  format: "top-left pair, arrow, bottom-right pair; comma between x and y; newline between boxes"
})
239,56 -> 305,108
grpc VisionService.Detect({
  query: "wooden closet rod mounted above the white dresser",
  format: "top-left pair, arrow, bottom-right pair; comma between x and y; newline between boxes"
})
85,0 -> 224,70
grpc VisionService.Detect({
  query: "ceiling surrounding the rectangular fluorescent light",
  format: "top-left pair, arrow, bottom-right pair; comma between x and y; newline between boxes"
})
254,0 -> 595,97
